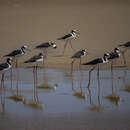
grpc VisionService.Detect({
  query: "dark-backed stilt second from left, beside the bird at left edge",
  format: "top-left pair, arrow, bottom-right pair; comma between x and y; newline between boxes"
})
4,46 -> 30,95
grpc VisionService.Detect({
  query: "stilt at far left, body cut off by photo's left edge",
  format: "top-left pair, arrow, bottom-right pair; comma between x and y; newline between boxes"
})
0,58 -> 12,110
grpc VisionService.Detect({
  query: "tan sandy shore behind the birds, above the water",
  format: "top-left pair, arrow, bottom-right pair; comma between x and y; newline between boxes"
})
0,0 -> 130,69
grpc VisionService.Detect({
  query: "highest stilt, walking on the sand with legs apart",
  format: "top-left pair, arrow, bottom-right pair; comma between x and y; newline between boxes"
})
57,29 -> 78,55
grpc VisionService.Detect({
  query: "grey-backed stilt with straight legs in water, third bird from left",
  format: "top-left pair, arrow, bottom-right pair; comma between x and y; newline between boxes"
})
24,53 -> 44,101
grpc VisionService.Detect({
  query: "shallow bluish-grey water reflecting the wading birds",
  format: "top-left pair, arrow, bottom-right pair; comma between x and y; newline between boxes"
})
0,68 -> 130,130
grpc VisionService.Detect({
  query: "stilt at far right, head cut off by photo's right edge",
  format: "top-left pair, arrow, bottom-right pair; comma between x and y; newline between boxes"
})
119,41 -> 130,66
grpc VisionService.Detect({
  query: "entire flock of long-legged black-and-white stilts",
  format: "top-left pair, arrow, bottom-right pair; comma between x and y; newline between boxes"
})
0,30 -> 130,106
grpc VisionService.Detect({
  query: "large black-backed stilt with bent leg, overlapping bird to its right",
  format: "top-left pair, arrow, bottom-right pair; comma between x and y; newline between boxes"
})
82,53 -> 110,87
